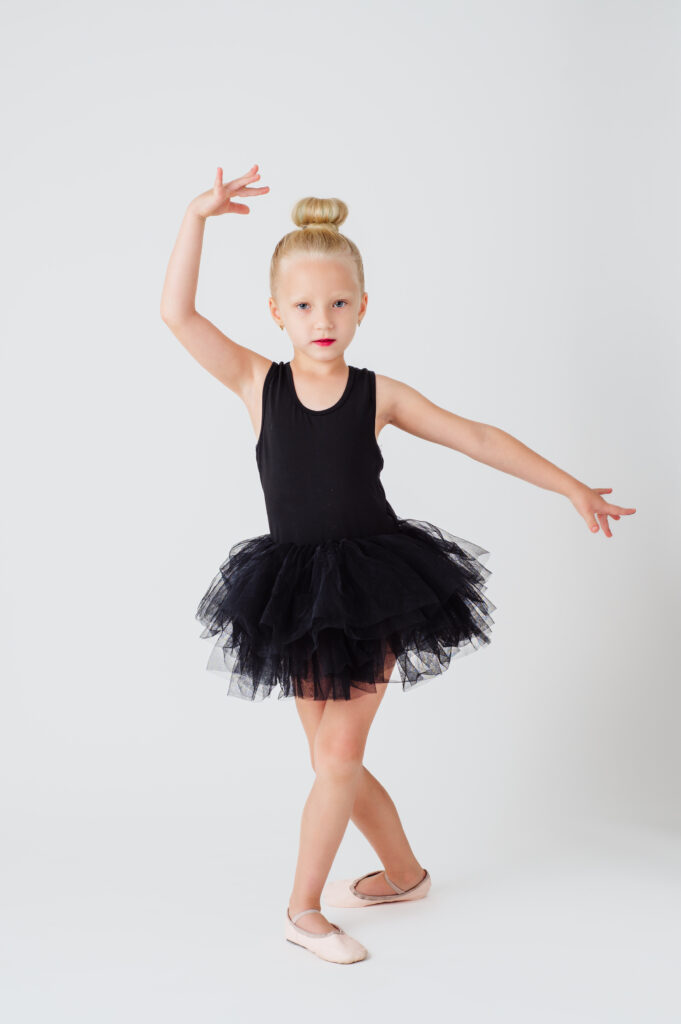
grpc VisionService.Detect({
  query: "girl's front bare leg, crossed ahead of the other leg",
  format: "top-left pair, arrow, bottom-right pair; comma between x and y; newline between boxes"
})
289,683 -> 391,933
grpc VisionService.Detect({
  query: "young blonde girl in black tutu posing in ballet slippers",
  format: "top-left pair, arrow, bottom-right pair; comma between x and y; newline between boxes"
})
161,164 -> 636,964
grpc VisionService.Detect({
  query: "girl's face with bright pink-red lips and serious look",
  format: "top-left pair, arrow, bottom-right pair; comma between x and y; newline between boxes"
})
269,256 -> 369,361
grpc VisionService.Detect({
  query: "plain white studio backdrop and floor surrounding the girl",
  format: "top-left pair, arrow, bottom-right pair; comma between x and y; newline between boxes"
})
0,0 -> 681,1024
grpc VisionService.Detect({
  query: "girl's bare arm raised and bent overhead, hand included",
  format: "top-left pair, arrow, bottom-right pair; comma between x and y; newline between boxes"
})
161,164 -> 269,400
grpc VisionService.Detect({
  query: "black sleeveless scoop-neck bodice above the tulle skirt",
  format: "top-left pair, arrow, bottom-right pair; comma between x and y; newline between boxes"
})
255,361 -> 397,544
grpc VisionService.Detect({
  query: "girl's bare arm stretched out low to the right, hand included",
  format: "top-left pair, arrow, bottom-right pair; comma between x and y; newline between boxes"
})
377,375 -> 636,537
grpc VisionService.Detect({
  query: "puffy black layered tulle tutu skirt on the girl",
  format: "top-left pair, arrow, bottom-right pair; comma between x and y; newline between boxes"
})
196,517 -> 496,700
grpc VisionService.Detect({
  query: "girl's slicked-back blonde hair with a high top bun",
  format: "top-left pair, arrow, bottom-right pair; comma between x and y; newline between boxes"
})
269,196 -> 365,296
